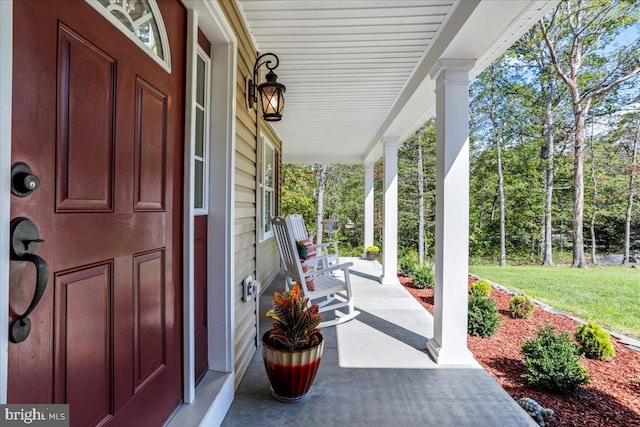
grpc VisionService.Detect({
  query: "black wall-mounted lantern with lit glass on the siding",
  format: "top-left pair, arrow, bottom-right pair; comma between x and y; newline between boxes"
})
245,53 -> 287,122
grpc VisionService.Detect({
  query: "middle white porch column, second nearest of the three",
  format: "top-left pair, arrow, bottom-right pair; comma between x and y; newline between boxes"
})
380,138 -> 400,285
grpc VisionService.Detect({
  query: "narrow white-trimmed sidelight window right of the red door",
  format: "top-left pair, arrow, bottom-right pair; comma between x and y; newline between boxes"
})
193,46 -> 211,215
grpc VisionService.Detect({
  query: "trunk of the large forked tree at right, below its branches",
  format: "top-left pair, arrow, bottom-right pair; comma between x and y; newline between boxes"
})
571,108 -> 587,268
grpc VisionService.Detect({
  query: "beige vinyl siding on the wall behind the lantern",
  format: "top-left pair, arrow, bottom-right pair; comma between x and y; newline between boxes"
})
218,0 -> 281,387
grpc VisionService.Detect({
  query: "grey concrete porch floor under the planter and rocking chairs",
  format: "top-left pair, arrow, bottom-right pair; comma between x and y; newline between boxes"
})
222,258 -> 537,427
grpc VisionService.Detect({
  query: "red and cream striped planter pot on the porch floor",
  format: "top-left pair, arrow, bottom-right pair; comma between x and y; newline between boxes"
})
262,332 -> 324,403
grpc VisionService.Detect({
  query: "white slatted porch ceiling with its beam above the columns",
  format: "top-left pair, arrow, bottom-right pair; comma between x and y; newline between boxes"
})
237,0 -> 557,163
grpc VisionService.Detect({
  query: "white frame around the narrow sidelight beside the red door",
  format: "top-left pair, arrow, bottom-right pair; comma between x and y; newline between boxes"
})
183,0 -> 237,420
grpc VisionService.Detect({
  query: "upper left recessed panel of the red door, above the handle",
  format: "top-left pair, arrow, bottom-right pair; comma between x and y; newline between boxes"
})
56,24 -> 116,212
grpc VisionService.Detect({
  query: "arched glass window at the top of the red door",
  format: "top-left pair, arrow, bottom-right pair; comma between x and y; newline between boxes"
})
85,0 -> 171,72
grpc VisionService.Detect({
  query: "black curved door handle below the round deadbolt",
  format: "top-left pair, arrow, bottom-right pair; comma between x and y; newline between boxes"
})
10,218 -> 49,343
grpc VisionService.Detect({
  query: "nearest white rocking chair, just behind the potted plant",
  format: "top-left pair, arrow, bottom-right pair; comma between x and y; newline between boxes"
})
271,217 -> 360,328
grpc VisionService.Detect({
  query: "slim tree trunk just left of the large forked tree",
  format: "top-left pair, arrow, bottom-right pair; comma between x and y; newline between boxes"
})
542,78 -> 555,265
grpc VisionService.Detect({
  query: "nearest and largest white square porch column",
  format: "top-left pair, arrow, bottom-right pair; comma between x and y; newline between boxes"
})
428,59 -> 475,365
